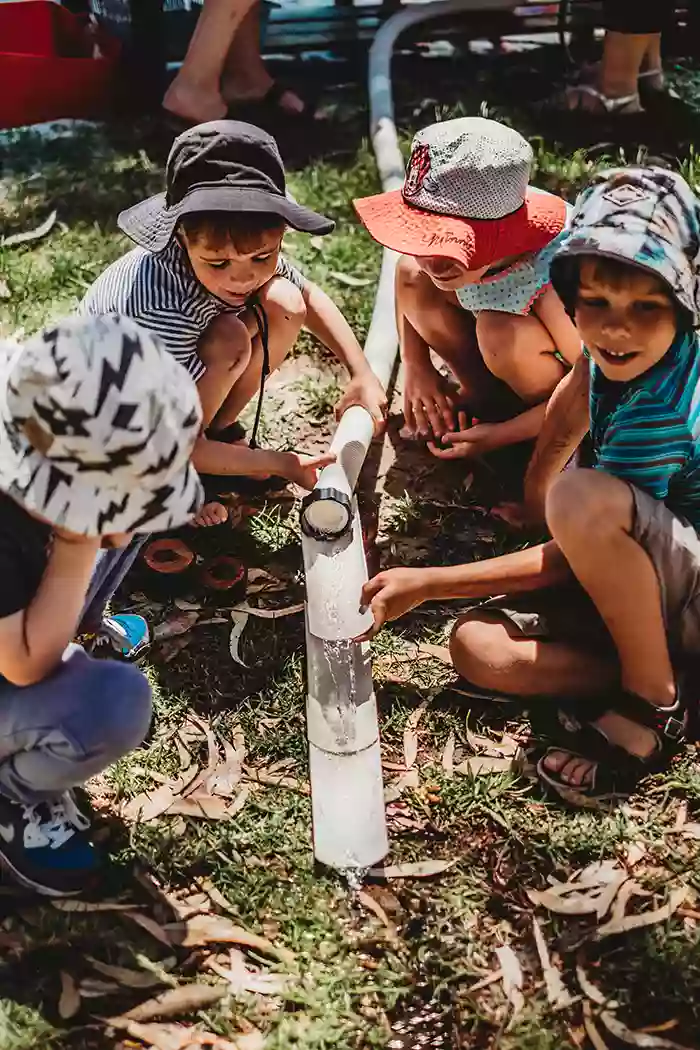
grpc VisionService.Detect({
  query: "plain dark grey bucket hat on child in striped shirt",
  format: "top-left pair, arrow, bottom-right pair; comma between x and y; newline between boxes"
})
118,121 -> 335,252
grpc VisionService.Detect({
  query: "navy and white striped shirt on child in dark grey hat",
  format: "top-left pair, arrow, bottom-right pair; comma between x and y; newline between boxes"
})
78,239 -> 305,381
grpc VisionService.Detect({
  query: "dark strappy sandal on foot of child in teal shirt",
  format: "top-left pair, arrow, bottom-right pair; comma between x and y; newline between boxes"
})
537,692 -> 687,810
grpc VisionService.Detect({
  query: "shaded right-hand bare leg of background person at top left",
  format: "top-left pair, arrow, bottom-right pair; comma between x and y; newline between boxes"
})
221,2 -> 304,116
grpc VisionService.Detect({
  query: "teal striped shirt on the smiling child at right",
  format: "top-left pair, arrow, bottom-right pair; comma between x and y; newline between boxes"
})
590,332 -> 700,532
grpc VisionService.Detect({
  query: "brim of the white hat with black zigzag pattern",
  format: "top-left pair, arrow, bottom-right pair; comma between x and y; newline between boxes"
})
0,430 -> 204,537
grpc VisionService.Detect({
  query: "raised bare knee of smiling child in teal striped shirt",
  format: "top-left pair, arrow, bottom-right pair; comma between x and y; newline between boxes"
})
545,468 -> 634,544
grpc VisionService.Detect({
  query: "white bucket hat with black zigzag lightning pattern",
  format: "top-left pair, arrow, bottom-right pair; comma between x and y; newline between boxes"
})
0,315 -> 203,536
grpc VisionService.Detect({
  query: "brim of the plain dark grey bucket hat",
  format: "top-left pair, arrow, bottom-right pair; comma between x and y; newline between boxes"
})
116,186 -> 335,252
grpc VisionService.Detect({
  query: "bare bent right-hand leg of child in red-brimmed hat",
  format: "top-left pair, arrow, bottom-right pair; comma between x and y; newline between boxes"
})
476,310 -> 565,405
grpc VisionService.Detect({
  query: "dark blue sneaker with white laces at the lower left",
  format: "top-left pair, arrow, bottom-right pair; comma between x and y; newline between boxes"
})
0,792 -> 100,897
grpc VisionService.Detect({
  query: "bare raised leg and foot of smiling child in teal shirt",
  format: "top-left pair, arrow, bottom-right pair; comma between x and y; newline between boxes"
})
547,470 -> 676,784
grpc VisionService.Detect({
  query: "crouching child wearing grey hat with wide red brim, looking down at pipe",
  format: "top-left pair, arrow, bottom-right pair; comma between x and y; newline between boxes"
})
355,118 -> 580,459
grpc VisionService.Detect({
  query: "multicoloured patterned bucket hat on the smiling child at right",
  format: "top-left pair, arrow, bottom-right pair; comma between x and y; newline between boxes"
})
552,168 -> 700,327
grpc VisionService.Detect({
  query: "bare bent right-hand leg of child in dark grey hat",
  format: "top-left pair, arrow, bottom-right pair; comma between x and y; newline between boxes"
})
210,277 -> 306,429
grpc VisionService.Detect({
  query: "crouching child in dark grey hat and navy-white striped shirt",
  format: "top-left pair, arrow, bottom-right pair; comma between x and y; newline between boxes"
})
81,121 -> 386,525
